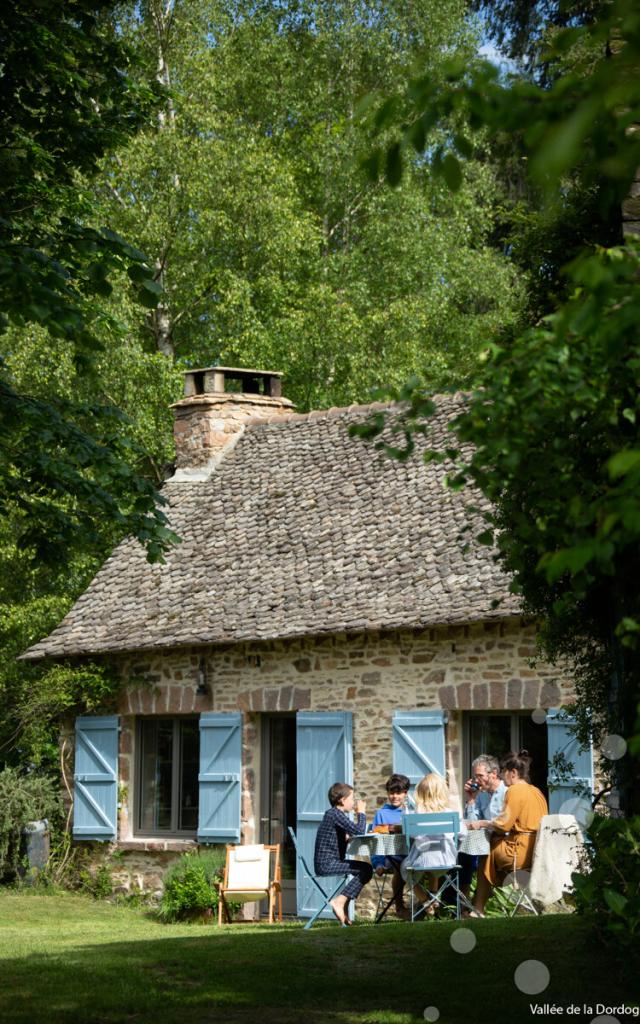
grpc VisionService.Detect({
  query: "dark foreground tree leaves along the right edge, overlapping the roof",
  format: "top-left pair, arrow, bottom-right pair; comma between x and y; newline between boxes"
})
354,0 -> 640,813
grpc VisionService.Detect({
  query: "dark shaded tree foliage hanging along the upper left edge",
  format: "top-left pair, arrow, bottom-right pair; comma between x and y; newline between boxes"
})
0,0 -> 174,559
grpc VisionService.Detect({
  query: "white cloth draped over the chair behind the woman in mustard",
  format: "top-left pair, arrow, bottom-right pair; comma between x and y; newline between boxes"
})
528,814 -> 585,906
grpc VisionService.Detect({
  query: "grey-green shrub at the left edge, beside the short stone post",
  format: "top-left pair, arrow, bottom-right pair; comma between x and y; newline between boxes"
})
0,768 -> 60,879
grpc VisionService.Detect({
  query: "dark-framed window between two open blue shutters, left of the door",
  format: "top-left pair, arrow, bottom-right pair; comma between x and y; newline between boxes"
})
135,718 -> 195,836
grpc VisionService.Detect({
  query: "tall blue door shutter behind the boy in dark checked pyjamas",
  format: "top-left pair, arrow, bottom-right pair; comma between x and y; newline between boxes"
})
296,712 -> 353,918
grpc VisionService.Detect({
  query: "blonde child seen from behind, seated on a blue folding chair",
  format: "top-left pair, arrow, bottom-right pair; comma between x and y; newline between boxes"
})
400,772 -> 464,918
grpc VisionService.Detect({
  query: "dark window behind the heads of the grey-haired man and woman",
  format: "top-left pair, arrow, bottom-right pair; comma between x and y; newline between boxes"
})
464,711 -> 548,796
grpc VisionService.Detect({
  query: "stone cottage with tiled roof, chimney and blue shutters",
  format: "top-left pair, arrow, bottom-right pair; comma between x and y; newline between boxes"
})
24,367 -> 591,915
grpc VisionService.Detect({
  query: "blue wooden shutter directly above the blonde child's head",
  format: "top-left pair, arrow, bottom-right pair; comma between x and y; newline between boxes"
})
392,711 -> 445,787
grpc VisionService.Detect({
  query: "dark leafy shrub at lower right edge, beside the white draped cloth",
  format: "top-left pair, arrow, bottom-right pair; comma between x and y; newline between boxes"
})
572,816 -> 640,957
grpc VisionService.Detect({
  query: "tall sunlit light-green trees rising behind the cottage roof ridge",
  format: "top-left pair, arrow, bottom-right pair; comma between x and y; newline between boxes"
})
93,0 -> 523,409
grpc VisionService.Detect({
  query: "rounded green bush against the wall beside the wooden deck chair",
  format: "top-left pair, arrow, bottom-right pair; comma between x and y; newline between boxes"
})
159,848 -> 226,922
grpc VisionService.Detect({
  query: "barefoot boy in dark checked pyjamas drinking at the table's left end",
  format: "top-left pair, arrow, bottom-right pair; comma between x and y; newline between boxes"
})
313,782 -> 374,925
